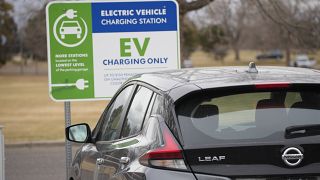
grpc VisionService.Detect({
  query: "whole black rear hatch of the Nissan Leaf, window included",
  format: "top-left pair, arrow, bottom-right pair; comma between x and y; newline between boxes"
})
176,84 -> 320,180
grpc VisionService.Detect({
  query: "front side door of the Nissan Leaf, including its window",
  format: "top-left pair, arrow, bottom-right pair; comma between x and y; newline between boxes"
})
80,85 -> 135,179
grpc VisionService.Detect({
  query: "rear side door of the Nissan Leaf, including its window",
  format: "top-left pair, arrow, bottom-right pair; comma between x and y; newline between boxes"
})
94,86 -> 153,180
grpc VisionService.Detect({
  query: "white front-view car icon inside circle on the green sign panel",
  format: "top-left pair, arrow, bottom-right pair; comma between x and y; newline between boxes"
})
59,21 -> 82,39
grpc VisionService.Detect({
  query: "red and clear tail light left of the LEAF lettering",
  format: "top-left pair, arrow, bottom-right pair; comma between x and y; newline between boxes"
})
139,125 -> 187,170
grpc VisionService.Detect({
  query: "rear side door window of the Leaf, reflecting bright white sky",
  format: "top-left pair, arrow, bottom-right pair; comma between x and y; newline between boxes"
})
121,86 -> 152,137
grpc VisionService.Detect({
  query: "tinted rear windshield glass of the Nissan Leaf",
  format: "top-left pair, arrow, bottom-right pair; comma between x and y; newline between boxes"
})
176,91 -> 320,145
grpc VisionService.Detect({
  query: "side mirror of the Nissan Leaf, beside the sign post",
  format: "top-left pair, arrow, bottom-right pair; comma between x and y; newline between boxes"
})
66,123 -> 91,143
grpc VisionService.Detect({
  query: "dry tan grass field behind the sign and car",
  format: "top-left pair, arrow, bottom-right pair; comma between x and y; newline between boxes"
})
0,51 -> 320,144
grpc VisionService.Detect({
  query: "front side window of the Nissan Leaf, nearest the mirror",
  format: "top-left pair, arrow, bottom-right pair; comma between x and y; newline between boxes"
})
97,85 -> 133,141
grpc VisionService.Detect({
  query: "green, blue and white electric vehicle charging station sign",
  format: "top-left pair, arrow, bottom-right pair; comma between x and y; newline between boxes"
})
46,0 -> 180,101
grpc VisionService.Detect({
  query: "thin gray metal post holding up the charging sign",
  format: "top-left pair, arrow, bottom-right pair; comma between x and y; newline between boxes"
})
64,101 -> 72,180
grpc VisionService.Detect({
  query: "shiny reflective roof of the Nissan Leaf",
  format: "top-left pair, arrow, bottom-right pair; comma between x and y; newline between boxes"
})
129,66 -> 320,100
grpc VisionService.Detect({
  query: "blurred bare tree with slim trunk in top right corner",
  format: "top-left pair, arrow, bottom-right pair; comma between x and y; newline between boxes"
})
255,0 -> 320,66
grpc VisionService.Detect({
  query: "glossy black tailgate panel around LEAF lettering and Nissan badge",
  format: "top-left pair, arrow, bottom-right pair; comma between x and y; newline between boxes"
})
185,142 -> 320,177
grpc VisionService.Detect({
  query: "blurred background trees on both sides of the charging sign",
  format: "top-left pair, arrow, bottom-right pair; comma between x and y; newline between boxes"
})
0,0 -> 320,67
